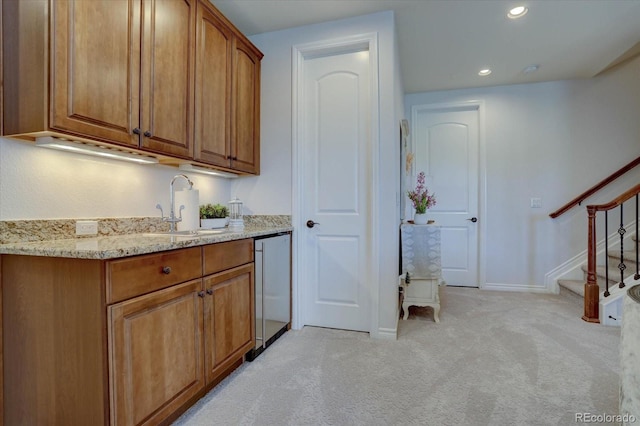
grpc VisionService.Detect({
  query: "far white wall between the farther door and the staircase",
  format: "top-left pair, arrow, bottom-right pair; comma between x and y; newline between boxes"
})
405,58 -> 640,290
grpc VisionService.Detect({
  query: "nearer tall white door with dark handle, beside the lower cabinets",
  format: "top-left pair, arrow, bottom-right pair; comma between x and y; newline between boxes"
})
299,51 -> 372,331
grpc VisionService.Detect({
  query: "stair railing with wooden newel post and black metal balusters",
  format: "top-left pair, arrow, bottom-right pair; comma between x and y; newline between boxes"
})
582,185 -> 640,323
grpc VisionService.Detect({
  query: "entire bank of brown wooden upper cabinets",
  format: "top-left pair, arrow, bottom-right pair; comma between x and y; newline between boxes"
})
2,0 -> 262,174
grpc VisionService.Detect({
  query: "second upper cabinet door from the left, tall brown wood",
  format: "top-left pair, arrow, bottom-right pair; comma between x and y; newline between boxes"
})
140,0 -> 196,158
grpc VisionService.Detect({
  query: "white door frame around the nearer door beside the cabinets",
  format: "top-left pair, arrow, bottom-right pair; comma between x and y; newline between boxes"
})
291,33 -> 380,337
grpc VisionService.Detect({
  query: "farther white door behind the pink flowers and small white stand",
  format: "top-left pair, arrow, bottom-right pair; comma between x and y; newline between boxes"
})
409,106 -> 482,287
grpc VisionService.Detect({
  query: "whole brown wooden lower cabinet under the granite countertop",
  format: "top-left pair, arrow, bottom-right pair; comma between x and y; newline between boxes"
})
0,239 -> 254,426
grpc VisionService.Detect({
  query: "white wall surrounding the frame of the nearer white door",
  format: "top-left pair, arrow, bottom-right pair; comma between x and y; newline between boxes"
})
248,12 -> 402,335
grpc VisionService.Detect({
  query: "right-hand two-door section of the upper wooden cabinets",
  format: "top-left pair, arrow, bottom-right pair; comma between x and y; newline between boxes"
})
195,0 -> 262,174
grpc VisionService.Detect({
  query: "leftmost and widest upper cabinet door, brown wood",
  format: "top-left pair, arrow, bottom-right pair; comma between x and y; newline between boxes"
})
49,0 -> 140,146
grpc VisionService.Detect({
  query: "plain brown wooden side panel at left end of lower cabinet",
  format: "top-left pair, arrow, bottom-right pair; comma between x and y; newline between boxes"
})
0,255 -> 109,426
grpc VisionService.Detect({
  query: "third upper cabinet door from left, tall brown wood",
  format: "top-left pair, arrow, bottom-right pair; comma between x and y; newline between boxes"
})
195,0 -> 232,167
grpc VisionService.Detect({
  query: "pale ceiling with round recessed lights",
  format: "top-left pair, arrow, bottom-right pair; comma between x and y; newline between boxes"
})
211,0 -> 640,93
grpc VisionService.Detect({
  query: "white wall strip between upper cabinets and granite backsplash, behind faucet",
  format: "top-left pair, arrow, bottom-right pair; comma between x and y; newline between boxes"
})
0,138 -> 231,220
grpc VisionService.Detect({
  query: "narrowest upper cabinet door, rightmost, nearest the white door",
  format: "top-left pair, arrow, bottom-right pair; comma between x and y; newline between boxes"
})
231,38 -> 262,174
